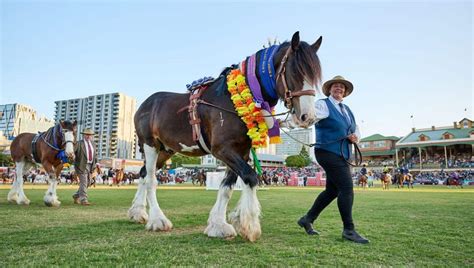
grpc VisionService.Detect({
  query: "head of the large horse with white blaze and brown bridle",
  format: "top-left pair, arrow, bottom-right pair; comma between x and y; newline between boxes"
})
276,32 -> 323,128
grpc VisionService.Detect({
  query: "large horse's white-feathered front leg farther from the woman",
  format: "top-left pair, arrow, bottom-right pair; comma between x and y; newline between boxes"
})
204,169 -> 237,238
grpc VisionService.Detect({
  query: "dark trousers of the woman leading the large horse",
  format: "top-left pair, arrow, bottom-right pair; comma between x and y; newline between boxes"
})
306,149 -> 354,230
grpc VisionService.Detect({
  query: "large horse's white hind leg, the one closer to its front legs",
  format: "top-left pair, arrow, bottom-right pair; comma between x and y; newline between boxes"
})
144,144 -> 173,231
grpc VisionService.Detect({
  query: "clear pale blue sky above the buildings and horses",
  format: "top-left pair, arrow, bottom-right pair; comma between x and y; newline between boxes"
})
0,1 -> 474,136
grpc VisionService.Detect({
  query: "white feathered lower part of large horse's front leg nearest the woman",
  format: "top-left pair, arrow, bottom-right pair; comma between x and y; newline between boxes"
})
229,184 -> 262,242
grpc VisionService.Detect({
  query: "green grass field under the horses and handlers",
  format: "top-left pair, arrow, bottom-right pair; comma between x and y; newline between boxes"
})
0,185 -> 474,267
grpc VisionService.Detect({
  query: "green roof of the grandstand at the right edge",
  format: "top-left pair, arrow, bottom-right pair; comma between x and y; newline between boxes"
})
395,127 -> 474,148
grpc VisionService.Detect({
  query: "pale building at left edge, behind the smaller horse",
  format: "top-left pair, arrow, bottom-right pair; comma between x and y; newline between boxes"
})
0,103 -> 54,141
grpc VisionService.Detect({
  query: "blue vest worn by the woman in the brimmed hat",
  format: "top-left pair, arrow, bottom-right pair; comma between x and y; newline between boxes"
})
315,98 -> 356,159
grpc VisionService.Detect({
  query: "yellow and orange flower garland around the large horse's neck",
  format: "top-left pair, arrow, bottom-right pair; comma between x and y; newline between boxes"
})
227,69 -> 268,149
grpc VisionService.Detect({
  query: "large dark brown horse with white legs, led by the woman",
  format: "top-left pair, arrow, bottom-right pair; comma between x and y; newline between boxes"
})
128,32 -> 322,241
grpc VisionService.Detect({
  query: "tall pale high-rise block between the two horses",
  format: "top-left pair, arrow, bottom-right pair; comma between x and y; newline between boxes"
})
54,93 -> 136,159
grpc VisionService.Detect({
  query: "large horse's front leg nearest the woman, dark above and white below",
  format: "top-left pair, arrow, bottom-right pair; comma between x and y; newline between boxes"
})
215,152 -> 262,242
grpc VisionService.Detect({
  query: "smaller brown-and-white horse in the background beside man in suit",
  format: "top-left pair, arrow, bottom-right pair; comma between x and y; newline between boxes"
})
8,120 -> 77,207
